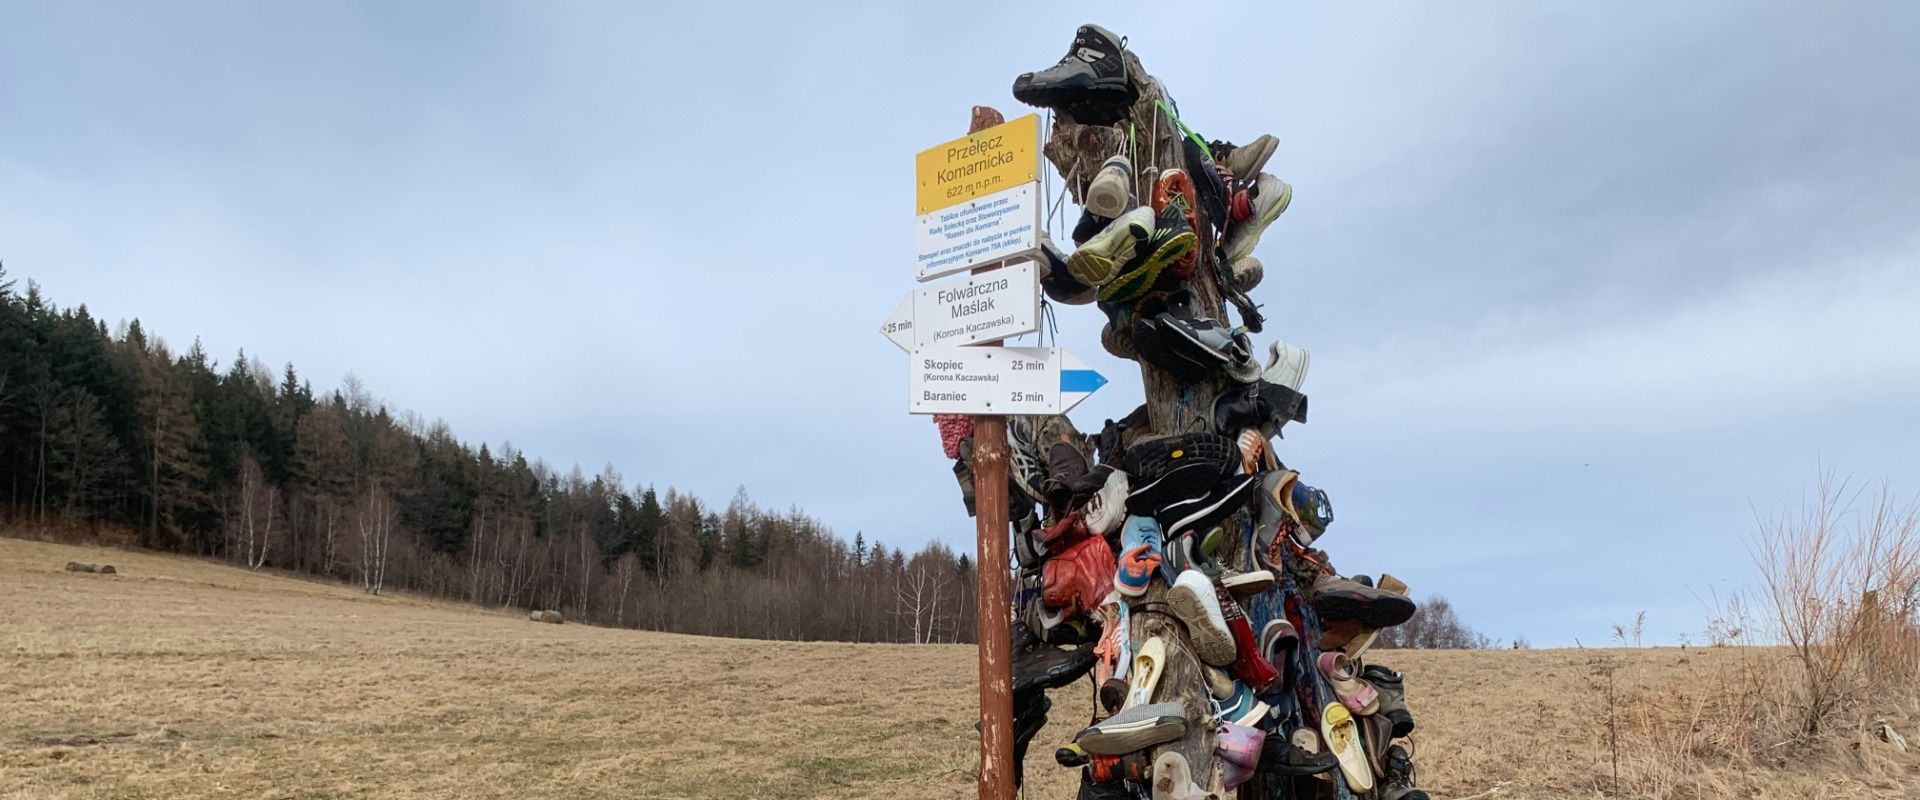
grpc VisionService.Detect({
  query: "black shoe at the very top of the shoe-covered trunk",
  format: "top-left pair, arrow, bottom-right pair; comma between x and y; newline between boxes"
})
1014,25 -> 1140,125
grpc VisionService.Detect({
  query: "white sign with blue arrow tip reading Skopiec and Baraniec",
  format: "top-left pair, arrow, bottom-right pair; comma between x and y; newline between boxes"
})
906,347 -> 1106,414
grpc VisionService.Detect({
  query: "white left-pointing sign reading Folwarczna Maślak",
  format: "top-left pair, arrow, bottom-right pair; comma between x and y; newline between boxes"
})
879,261 -> 1041,351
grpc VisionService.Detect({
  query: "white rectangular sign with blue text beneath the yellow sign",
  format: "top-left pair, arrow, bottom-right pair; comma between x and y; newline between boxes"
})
914,180 -> 1041,280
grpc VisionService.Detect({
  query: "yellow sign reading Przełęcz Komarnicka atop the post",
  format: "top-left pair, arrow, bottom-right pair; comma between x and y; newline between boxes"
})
914,113 -> 1041,215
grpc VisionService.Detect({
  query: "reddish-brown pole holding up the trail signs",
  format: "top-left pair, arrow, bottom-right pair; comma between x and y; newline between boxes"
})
968,106 -> 1014,800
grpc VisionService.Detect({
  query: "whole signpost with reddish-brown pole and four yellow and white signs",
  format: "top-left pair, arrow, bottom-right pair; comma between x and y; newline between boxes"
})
879,106 -> 1106,800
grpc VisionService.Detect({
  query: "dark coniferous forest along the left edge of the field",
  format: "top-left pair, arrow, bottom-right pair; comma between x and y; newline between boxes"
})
0,267 -> 973,643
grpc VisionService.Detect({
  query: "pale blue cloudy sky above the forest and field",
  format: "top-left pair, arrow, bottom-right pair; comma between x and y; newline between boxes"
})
0,0 -> 1920,647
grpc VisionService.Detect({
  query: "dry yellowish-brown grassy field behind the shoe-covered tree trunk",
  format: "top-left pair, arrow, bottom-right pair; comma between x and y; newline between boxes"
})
0,539 -> 1920,800
